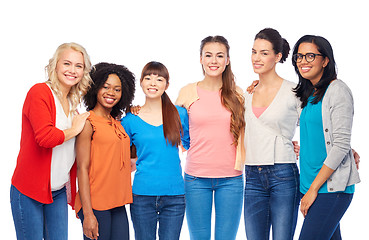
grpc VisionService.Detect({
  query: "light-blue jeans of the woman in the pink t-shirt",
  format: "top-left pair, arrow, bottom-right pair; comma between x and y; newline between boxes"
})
184,174 -> 243,240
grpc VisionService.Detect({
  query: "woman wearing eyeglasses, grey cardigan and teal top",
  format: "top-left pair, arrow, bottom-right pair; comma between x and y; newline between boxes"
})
293,35 -> 360,240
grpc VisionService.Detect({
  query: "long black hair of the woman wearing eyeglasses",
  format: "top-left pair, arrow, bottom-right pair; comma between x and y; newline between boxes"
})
292,35 -> 337,108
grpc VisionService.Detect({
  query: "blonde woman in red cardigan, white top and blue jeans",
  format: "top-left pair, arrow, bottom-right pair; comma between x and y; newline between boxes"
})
10,43 -> 91,240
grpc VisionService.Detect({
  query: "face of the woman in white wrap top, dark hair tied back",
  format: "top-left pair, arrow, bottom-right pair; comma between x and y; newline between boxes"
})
251,39 -> 282,74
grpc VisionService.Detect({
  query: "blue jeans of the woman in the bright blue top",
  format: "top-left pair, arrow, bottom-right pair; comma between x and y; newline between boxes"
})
131,194 -> 186,240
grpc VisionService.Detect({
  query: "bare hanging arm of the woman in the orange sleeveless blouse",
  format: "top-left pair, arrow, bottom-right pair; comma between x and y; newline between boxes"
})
76,120 -> 99,239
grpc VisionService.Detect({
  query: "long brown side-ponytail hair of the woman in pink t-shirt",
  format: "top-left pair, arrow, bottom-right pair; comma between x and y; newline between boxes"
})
200,36 -> 245,145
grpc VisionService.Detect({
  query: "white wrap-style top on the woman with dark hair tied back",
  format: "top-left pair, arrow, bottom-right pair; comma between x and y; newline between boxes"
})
245,80 -> 301,166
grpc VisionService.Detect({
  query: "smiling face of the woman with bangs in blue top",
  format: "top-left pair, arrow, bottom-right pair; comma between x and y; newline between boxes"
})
140,74 -> 169,98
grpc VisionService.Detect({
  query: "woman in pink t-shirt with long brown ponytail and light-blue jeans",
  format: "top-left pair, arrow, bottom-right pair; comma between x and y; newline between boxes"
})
176,36 -> 245,239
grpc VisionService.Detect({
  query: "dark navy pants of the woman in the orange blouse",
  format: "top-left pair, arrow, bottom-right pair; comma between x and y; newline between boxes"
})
78,206 -> 129,240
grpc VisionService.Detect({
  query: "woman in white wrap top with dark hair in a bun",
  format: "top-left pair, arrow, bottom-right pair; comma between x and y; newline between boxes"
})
244,28 -> 300,240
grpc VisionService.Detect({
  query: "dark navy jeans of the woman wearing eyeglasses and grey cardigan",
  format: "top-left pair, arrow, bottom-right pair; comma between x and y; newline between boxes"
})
299,193 -> 353,240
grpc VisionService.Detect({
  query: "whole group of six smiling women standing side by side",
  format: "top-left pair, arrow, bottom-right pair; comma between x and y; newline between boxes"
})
11,28 -> 360,240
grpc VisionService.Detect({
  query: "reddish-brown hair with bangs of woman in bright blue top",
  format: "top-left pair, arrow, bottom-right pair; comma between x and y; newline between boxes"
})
140,61 -> 183,147
